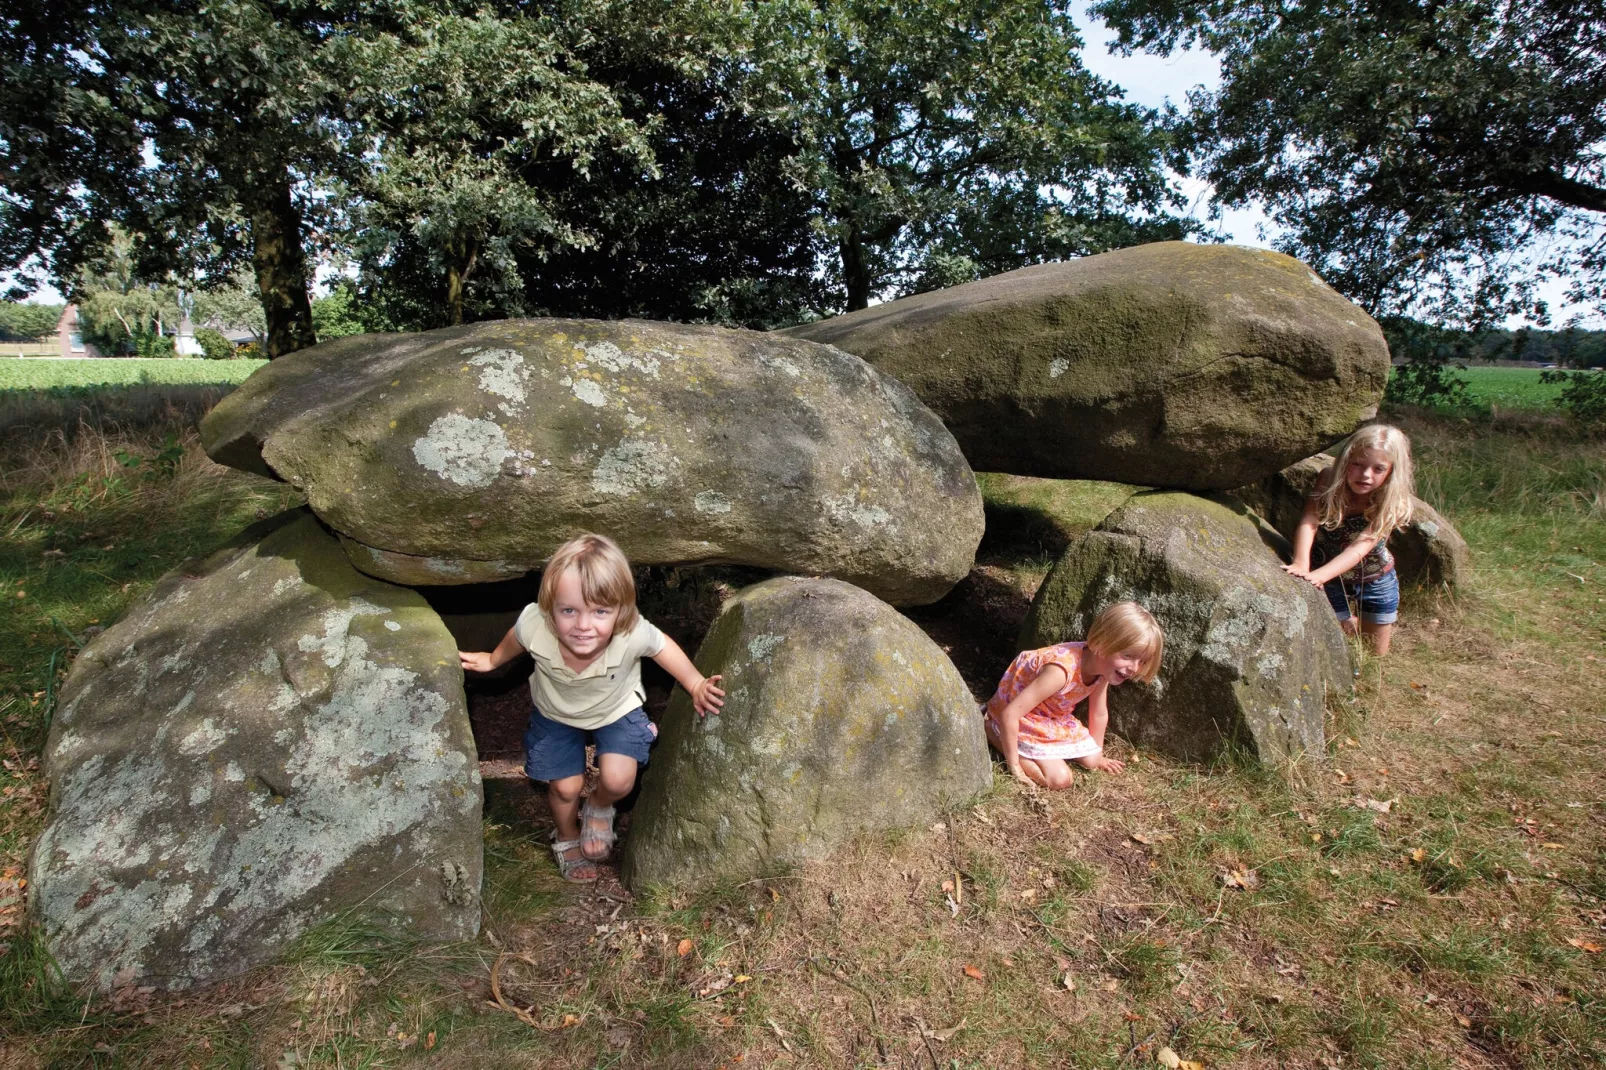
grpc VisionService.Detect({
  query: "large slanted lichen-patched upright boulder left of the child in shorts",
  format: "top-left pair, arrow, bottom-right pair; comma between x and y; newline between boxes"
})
29,511 -> 482,990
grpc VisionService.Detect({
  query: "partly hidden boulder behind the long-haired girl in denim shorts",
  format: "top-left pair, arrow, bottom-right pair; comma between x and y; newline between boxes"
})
1232,453 -> 1471,588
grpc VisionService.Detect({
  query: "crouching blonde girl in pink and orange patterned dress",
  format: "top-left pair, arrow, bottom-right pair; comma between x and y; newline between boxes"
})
983,602 -> 1166,790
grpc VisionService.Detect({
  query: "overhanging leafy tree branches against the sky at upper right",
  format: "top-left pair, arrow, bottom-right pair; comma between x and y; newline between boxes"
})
1092,0 -> 1606,325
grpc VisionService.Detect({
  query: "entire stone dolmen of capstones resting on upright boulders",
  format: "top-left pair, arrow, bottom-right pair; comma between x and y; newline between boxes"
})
29,243 -> 1455,990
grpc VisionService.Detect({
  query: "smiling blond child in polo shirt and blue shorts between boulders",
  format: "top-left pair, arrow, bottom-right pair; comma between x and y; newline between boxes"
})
458,535 -> 724,882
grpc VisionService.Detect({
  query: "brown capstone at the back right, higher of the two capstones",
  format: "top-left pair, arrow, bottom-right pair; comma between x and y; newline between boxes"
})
787,241 -> 1389,490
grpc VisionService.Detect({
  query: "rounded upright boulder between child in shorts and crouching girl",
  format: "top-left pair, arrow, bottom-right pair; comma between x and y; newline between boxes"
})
623,577 -> 993,888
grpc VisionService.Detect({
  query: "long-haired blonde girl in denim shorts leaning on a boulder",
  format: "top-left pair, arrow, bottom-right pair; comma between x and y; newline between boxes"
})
1283,424 -> 1413,654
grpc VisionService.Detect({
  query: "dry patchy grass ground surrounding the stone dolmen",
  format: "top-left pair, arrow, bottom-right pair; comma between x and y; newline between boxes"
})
0,401 -> 1606,1070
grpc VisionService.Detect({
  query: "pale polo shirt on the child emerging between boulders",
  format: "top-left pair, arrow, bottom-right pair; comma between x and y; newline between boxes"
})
512,602 -> 663,731
